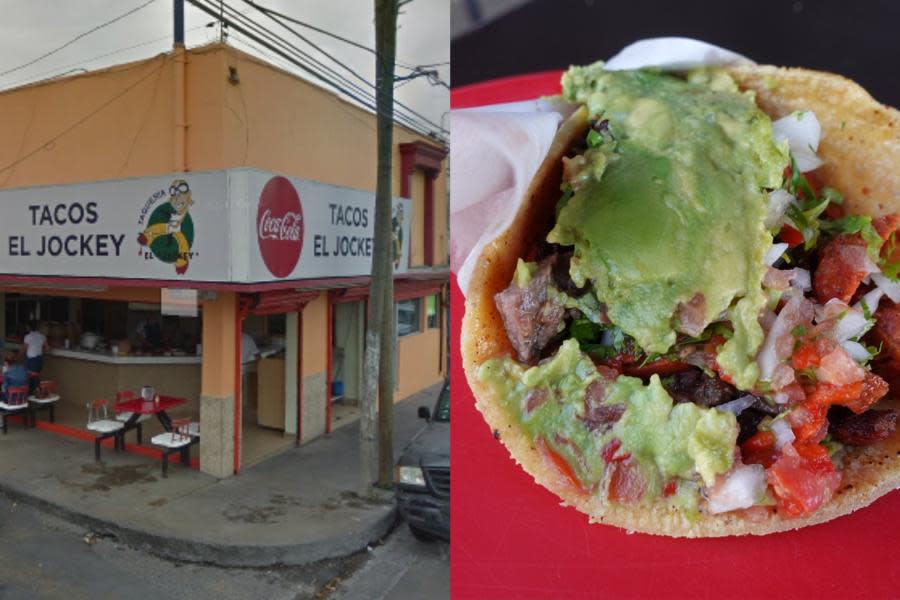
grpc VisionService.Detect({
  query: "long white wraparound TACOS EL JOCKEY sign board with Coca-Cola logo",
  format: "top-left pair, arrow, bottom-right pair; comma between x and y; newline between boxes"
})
0,169 -> 412,287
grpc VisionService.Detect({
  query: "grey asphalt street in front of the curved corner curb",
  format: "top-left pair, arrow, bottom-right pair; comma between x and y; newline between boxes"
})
0,496 -> 450,600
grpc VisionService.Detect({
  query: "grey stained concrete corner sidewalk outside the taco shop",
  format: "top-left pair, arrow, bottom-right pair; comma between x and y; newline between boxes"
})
0,386 -> 440,567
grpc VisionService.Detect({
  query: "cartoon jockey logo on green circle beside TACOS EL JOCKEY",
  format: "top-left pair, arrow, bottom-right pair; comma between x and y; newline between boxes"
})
138,179 -> 194,275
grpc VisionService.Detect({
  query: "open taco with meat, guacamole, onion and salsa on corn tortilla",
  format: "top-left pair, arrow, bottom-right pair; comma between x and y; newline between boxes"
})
460,63 -> 900,537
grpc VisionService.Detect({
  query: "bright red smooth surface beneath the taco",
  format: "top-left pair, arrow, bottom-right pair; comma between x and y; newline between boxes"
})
450,73 -> 900,599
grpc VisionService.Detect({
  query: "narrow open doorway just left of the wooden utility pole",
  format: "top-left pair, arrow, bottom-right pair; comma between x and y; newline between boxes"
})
331,300 -> 366,430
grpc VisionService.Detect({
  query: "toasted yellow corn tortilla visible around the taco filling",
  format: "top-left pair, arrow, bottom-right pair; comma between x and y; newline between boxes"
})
460,66 -> 900,537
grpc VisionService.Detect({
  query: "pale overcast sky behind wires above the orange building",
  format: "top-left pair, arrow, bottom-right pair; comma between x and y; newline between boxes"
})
0,0 -> 450,139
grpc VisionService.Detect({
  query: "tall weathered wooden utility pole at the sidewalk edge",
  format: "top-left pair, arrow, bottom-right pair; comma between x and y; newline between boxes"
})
359,0 -> 400,491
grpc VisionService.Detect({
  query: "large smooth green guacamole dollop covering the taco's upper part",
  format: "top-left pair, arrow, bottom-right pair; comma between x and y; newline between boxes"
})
548,63 -> 788,389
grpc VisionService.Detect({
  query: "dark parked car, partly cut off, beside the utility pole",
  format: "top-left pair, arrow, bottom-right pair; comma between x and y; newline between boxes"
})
395,381 -> 450,541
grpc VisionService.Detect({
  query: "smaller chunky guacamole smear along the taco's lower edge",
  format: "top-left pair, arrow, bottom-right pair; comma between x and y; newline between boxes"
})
478,339 -> 738,505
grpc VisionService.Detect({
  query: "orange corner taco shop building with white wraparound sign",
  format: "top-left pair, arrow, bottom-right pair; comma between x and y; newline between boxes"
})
0,44 -> 447,477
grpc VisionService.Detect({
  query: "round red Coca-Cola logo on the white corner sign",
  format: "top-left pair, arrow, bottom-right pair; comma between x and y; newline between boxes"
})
256,176 -> 303,277
